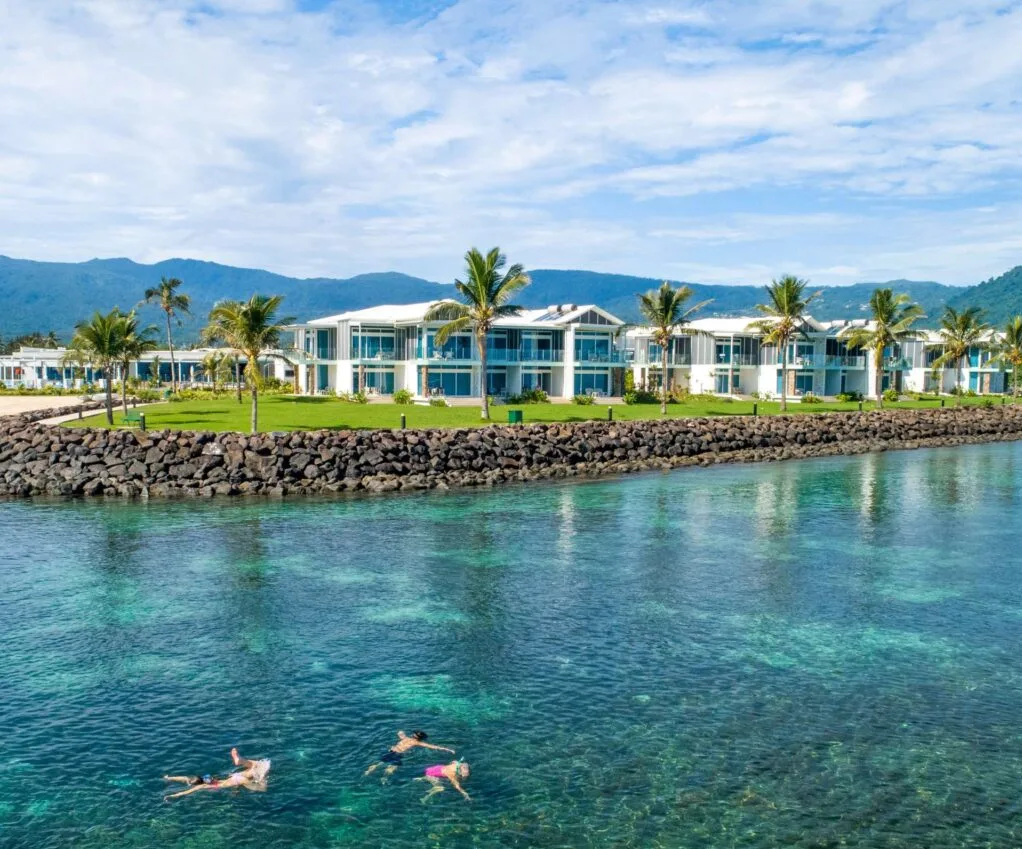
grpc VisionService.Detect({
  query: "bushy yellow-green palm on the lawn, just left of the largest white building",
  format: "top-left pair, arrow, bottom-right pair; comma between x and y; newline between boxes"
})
203,294 -> 294,433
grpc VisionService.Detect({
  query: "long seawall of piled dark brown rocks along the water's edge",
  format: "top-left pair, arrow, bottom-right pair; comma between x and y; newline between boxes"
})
0,407 -> 1022,498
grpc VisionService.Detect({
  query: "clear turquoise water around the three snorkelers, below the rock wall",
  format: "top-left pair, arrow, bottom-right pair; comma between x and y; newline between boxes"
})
0,444 -> 1022,849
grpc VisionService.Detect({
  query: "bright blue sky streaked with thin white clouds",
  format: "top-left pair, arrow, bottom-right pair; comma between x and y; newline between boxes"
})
0,0 -> 1022,285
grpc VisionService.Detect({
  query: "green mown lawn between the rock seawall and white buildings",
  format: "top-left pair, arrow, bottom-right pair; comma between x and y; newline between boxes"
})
59,395 -> 1001,431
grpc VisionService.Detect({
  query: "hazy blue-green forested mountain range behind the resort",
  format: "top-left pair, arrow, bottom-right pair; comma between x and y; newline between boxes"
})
0,255 -> 1022,341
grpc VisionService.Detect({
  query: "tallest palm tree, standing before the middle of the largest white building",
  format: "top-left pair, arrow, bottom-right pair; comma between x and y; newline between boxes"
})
424,247 -> 531,419
